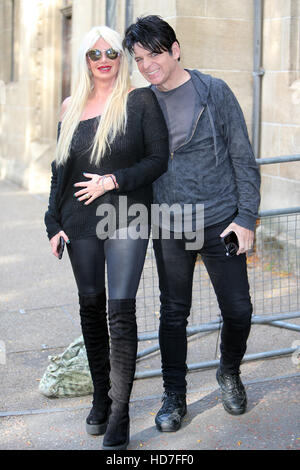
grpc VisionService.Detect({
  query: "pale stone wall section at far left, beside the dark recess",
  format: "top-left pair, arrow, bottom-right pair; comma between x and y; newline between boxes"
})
0,0 -> 61,191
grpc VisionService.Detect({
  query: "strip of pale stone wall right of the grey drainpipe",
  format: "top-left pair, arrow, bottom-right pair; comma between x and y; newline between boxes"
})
261,0 -> 300,209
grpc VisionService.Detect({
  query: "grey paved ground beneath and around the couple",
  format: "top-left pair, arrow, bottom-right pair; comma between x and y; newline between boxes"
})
0,181 -> 300,454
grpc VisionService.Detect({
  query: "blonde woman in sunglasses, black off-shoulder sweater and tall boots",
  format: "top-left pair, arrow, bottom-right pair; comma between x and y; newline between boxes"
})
45,26 -> 168,450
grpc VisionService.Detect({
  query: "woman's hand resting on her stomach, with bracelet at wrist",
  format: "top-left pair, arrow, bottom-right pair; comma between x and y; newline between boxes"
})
74,173 -> 117,206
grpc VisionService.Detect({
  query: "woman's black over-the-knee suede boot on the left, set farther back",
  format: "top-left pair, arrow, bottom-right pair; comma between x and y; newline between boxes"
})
79,291 -> 111,435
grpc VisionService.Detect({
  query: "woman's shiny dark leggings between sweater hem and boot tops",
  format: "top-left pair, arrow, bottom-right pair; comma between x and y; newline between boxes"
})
67,228 -> 149,299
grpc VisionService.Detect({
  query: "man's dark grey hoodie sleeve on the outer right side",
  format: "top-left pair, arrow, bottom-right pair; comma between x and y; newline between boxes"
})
213,80 -> 261,230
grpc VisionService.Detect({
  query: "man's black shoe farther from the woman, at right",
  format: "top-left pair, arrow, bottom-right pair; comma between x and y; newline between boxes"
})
217,369 -> 247,415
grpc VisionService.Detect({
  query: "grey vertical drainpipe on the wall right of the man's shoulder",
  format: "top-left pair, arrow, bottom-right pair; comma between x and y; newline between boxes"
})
252,0 -> 265,158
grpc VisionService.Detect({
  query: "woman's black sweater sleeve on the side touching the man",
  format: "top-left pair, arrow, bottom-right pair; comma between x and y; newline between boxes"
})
114,88 -> 169,191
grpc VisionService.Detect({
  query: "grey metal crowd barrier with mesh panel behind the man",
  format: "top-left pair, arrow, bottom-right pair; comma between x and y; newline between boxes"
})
135,155 -> 300,379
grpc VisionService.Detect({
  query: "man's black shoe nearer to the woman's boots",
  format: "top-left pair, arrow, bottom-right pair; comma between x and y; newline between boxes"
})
155,392 -> 186,432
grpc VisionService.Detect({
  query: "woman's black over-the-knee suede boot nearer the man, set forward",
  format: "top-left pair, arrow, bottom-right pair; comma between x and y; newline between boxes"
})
102,299 -> 137,450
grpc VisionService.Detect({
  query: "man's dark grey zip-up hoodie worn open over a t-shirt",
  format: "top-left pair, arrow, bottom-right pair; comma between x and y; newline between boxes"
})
153,70 -> 260,230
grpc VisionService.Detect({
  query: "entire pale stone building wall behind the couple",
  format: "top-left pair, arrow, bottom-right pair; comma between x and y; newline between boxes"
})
0,0 -> 300,208
